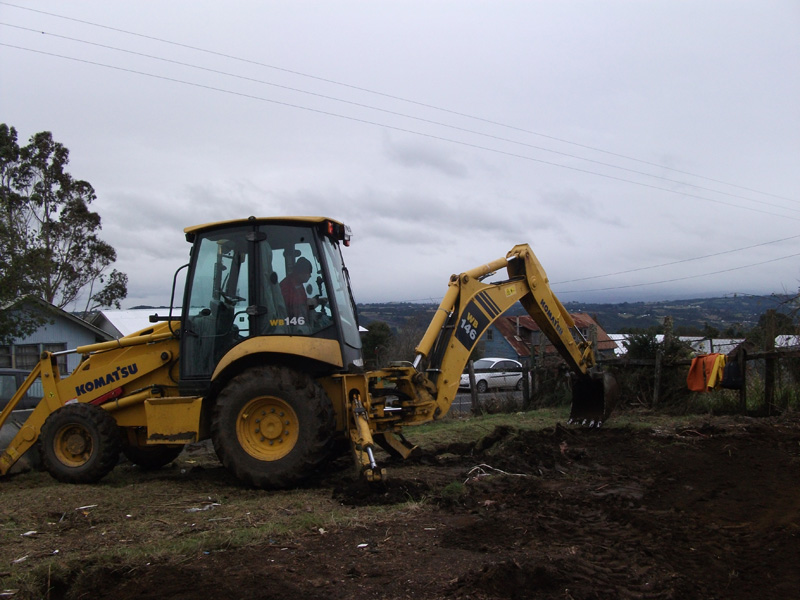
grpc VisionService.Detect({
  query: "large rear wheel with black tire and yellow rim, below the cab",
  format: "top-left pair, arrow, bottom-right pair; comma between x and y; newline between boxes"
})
211,366 -> 335,489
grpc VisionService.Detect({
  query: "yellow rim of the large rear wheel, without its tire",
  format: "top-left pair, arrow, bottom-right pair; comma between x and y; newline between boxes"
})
236,396 -> 300,461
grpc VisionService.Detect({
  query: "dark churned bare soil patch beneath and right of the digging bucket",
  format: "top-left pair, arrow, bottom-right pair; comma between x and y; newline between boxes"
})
3,418 -> 800,600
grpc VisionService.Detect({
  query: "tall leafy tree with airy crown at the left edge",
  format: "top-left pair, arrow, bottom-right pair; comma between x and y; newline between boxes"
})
0,124 -> 128,339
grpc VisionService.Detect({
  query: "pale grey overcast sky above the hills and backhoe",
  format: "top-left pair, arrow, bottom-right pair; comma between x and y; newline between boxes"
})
0,0 -> 800,307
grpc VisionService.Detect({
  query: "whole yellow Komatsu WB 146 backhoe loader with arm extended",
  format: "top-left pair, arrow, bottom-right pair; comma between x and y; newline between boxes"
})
0,217 -> 613,488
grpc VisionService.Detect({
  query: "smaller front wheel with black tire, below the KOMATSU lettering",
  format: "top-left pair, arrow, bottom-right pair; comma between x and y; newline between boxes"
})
39,404 -> 121,483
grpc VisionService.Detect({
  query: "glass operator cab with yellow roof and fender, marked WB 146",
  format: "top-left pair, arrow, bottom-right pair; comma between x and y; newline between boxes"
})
180,217 -> 363,393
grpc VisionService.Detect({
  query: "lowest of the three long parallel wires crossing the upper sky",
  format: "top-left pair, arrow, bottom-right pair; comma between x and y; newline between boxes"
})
0,42 -> 800,221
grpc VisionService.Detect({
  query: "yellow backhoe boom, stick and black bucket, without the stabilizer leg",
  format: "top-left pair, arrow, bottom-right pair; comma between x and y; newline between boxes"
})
367,244 -> 615,436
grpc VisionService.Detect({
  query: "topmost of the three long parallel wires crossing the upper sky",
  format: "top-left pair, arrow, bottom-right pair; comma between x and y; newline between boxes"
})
0,1 -> 800,202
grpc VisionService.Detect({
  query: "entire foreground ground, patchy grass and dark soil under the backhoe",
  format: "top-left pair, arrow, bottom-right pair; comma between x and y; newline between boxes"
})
0,415 -> 800,600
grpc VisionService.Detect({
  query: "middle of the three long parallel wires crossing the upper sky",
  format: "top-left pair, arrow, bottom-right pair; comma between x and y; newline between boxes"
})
0,22 -> 800,213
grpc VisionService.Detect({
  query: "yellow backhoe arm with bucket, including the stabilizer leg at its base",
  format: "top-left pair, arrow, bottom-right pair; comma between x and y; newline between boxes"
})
337,244 -> 617,481
